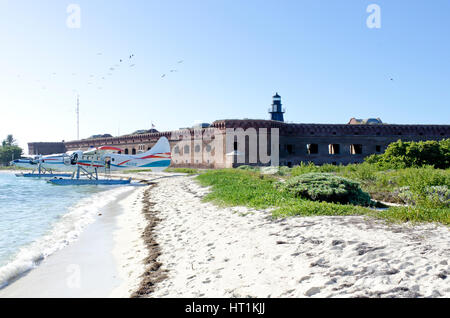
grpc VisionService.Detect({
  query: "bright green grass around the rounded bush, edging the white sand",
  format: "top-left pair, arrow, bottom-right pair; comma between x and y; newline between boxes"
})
197,166 -> 450,225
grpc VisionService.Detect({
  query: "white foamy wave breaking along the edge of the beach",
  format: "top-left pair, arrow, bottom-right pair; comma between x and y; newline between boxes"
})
0,187 -> 131,289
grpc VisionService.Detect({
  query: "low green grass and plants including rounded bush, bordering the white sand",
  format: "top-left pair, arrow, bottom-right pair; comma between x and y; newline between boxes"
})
197,163 -> 450,225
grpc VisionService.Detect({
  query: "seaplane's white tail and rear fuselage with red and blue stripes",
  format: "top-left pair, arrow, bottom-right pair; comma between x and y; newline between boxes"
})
109,137 -> 172,172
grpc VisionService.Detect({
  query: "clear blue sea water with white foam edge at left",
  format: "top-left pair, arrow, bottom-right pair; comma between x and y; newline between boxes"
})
0,173 -> 128,288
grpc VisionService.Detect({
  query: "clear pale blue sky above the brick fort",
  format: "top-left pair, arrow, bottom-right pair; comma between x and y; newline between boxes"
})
0,0 -> 450,152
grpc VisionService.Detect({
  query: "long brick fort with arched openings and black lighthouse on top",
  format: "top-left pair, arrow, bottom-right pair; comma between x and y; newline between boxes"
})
28,93 -> 450,168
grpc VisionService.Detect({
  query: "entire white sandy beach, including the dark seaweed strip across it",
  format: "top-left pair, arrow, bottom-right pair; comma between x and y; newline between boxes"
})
0,173 -> 450,298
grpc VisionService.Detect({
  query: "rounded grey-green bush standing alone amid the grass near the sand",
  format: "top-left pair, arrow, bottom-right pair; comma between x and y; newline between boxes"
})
280,172 -> 371,206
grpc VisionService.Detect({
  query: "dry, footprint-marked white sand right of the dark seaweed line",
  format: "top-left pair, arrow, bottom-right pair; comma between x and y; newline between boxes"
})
146,177 -> 450,297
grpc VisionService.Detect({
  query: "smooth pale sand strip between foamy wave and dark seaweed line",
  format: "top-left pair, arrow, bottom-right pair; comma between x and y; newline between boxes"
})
0,187 -> 146,298
